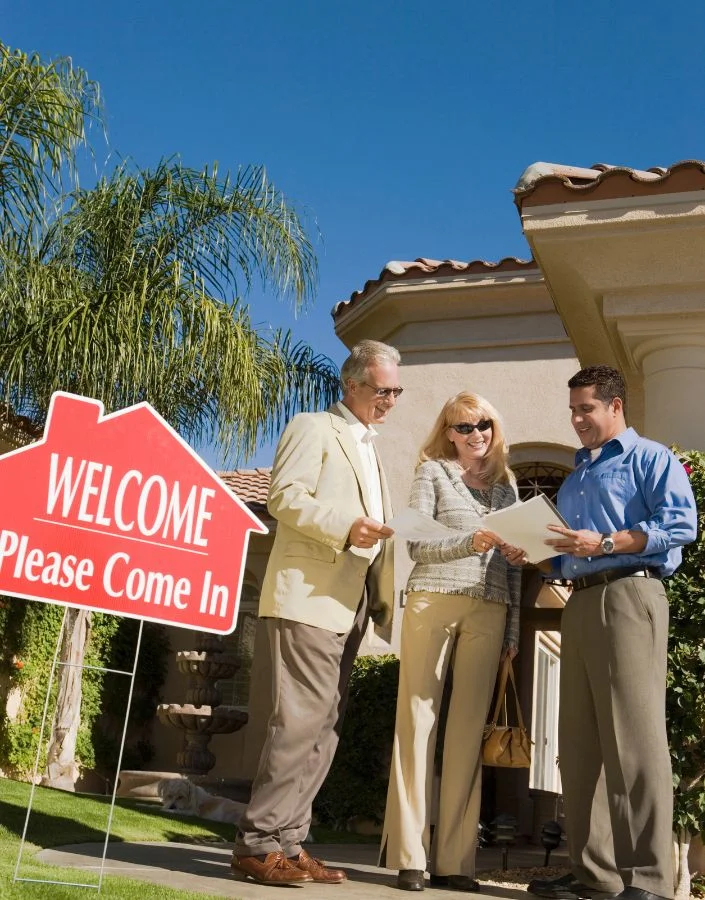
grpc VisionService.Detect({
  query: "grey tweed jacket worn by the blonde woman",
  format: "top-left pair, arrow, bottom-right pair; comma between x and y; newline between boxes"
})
406,459 -> 521,647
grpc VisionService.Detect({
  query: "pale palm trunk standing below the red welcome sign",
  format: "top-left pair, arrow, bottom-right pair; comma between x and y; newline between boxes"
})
42,607 -> 91,791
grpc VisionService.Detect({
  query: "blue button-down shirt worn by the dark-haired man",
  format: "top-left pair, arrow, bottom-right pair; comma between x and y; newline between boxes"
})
555,428 -> 697,579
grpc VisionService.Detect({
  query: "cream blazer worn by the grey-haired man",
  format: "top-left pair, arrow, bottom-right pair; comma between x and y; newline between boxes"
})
259,407 -> 394,634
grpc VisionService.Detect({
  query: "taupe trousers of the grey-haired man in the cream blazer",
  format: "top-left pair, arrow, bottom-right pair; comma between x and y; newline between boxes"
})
235,596 -> 369,856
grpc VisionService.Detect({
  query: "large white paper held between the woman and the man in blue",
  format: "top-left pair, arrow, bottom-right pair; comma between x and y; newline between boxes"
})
482,494 -> 568,563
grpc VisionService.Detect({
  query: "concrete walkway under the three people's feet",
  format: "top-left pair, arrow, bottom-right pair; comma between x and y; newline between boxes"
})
38,842 -> 567,900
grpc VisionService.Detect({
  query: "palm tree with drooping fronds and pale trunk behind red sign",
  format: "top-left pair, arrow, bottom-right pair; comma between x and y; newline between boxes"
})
0,44 -> 338,789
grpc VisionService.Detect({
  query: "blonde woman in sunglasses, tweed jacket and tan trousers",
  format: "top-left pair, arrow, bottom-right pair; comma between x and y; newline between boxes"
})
382,391 -> 525,891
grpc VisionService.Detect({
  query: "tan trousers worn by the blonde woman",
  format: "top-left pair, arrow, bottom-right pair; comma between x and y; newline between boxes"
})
382,592 -> 507,877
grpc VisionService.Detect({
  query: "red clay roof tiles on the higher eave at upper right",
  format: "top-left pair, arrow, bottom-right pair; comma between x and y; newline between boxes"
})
514,159 -> 705,209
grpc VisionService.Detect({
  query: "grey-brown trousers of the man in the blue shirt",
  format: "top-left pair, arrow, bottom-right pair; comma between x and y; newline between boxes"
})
559,577 -> 673,898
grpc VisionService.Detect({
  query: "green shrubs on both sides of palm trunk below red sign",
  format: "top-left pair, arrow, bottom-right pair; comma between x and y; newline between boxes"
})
0,597 -> 169,781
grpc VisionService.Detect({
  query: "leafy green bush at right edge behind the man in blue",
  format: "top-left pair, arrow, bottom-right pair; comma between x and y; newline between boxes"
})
666,451 -> 705,834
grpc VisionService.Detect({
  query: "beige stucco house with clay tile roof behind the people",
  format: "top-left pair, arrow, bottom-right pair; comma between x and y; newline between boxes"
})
154,161 -> 705,834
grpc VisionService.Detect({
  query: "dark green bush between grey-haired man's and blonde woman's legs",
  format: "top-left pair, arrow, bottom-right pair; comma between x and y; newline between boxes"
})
314,655 -> 399,828
